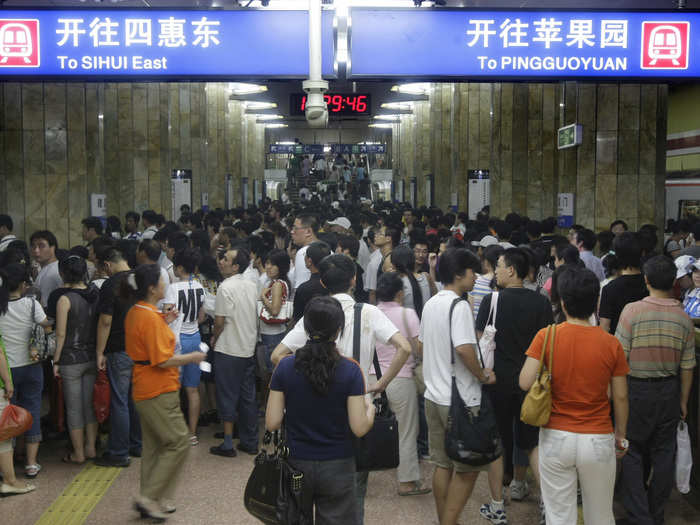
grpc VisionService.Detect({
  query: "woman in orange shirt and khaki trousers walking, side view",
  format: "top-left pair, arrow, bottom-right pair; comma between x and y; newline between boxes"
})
121,264 -> 205,521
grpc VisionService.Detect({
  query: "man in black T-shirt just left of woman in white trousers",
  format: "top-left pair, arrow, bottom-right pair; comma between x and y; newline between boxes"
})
476,248 -> 553,522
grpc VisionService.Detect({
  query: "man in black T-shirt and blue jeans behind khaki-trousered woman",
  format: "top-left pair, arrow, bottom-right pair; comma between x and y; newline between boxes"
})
95,247 -> 141,467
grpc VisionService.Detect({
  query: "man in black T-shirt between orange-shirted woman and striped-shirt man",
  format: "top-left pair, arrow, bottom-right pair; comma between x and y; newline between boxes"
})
598,232 -> 649,334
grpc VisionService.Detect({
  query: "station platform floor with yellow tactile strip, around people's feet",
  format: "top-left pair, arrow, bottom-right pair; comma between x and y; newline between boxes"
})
0,426 -> 700,525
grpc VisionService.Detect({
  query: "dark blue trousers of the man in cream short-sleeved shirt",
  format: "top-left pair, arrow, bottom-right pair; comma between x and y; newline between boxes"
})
214,352 -> 259,450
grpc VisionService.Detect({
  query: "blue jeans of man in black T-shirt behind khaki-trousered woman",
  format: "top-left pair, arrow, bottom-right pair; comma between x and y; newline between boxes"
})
105,352 -> 141,459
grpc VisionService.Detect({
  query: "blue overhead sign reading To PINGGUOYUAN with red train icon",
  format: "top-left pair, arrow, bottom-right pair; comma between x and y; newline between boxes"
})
350,8 -> 700,80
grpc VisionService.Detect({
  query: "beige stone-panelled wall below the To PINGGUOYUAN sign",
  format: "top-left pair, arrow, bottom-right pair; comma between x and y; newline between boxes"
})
393,82 -> 668,230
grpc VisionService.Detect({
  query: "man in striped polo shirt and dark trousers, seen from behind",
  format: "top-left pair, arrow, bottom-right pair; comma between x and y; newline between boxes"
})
615,255 -> 696,525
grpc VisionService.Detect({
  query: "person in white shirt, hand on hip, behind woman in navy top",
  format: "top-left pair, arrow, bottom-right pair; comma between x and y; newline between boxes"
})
271,254 -> 411,524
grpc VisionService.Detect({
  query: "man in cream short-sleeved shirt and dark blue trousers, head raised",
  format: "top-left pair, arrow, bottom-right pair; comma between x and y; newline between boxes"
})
209,247 -> 258,457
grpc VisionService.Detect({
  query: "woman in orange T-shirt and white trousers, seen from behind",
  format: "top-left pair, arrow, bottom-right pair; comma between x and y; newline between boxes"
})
520,268 -> 629,525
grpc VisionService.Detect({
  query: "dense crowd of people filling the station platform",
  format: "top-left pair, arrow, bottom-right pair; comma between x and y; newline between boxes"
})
0,199 -> 700,525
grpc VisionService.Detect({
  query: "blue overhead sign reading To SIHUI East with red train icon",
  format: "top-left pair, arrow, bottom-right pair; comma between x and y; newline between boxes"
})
0,9 -> 334,79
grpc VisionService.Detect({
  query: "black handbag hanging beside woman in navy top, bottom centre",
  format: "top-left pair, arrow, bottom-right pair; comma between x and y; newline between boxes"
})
243,432 -> 312,525
